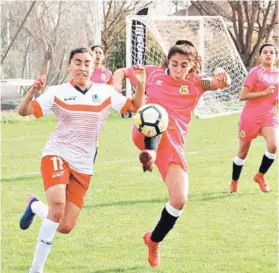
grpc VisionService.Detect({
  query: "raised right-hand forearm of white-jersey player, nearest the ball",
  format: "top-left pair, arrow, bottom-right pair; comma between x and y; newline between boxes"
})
128,65 -> 146,112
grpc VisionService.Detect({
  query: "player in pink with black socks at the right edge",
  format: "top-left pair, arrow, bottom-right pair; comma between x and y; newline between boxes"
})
230,43 -> 278,192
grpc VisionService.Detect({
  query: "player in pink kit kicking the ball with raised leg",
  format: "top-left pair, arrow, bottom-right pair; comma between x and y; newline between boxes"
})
114,40 -> 230,267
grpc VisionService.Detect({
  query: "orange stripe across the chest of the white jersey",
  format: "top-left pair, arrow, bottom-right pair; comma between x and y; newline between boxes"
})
54,97 -> 111,112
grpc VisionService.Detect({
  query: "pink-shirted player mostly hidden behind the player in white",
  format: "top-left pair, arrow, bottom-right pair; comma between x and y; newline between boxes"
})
90,45 -> 112,84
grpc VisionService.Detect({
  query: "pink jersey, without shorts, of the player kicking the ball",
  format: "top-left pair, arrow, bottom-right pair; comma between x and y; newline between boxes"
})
128,66 -> 204,140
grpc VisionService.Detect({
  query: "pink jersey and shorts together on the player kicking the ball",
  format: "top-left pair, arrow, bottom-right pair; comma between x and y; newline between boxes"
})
127,66 -> 209,177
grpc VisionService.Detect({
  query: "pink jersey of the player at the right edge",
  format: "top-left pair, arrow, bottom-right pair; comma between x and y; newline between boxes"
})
241,65 -> 278,121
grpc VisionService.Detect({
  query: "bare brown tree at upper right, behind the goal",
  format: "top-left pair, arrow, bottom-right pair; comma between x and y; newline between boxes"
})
188,1 -> 278,68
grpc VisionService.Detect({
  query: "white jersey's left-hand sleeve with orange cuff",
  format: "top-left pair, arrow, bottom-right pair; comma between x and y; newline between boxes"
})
32,87 -> 55,118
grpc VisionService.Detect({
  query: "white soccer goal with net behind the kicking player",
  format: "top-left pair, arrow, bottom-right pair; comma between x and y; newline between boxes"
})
126,16 -> 247,118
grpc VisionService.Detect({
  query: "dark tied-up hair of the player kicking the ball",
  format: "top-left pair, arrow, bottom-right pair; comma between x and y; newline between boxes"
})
163,40 -> 201,73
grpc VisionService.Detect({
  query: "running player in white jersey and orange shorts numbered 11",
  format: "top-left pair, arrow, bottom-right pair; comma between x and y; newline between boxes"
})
18,47 -> 145,273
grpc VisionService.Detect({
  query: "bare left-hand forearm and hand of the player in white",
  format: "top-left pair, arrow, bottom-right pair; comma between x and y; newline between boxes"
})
18,75 -> 46,117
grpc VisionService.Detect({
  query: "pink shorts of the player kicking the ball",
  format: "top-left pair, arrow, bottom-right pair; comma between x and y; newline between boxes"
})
132,127 -> 188,180
